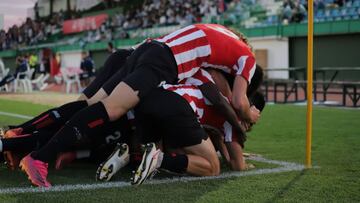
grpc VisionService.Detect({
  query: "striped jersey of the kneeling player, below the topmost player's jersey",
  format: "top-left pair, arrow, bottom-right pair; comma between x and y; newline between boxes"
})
163,85 -> 236,142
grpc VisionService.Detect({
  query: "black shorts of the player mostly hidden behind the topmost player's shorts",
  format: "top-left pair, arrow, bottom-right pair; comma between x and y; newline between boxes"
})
83,49 -> 134,98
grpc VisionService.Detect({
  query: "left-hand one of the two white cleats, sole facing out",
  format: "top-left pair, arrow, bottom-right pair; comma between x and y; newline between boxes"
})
96,143 -> 130,181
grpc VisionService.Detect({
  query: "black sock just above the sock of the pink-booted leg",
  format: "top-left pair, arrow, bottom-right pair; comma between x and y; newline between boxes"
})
22,101 -> 88,134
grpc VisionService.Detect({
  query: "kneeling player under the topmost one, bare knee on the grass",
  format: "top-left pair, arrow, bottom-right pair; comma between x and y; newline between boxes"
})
132,85 -> 264,185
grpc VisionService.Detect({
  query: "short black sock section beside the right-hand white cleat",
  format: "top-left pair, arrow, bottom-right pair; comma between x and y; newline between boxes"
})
160,154 -> 189,174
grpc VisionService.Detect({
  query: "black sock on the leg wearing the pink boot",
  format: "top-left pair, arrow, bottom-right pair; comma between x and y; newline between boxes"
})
31,102 -> 109,162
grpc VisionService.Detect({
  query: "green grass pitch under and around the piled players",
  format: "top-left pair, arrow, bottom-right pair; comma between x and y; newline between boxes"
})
0,97 -> 360,202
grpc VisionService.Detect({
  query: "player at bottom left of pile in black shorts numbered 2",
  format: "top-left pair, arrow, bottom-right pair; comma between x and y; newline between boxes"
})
0,114 -> 134,170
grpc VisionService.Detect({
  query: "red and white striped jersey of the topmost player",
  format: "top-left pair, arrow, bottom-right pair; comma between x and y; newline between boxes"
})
156,24 -> 255,83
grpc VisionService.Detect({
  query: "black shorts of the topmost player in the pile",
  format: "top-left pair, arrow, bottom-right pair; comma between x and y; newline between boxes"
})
103,41 -> 177,99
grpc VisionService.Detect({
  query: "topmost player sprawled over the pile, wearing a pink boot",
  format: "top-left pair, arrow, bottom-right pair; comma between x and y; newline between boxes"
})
17,24 -> 260,186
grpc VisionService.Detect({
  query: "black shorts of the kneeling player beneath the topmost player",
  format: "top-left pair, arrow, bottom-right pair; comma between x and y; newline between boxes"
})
135,88 -> 208,148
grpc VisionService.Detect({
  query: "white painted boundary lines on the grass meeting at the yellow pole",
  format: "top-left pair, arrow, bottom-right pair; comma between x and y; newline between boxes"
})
0,156 -> 305,194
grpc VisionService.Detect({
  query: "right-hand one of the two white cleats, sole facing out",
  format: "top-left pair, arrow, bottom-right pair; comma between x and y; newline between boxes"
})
131,143 -> 161,185
